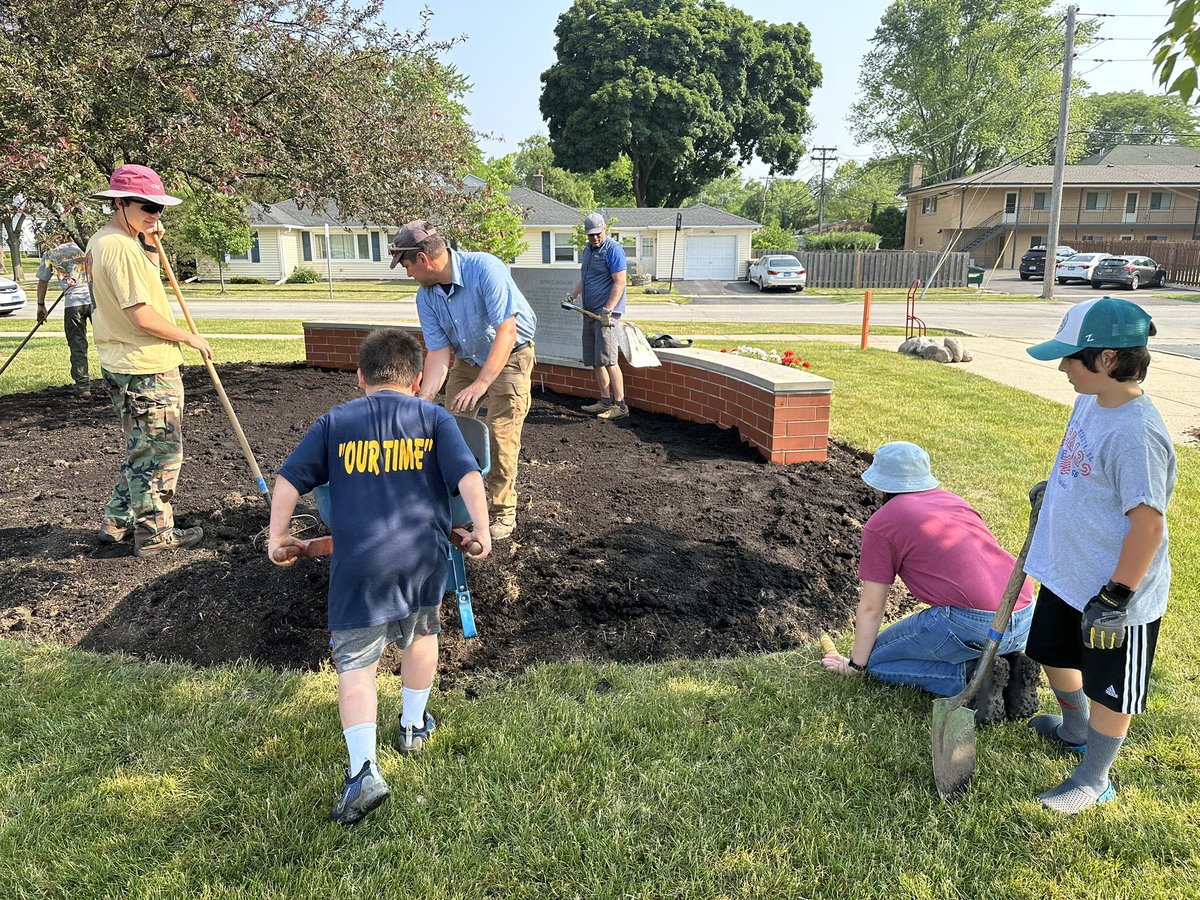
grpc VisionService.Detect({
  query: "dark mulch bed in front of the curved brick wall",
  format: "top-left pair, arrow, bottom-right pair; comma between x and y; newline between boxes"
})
0,364 -> 902,683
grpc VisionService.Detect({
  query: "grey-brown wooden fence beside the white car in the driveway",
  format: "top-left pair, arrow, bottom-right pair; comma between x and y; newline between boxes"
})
754,250 -> 971,288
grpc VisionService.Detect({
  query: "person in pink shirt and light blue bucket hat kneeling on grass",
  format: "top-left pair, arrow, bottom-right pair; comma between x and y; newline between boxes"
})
822,440 -> 1040,725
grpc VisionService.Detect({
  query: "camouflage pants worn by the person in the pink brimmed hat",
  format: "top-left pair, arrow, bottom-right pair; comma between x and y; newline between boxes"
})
101,368 -> 184,545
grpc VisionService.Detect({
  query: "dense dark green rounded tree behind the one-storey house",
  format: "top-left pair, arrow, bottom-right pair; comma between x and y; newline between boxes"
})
541,0 -> 821,206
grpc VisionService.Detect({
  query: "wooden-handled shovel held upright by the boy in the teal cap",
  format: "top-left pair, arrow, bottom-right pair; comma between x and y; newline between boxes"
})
934,490 -> 1042,799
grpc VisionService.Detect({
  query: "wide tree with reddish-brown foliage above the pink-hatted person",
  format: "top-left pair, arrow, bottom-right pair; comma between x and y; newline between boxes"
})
0,0 -> 496,264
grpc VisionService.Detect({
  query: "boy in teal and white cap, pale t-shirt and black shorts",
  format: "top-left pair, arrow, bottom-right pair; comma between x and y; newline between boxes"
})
1025,296 -> 1176,815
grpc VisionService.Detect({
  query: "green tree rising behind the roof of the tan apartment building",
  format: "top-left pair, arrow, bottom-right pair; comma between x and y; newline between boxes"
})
1084,91 -> 1200,154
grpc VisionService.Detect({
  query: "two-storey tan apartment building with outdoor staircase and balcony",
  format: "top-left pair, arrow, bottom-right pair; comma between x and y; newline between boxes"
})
905,145 -> 1200,269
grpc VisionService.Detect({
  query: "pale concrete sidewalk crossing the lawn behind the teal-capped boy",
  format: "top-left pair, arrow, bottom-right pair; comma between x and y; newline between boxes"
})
674,329 -> 1200,445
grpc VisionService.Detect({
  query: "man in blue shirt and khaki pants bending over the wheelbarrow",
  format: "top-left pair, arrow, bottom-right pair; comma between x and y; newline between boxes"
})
389,220 -> 538,540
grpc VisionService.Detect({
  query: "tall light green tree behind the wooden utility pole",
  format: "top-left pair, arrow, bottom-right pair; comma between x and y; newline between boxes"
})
851,0 -> 1096,181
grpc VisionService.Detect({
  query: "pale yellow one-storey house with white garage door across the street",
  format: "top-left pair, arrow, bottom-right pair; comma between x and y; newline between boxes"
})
197,181 -> 758,282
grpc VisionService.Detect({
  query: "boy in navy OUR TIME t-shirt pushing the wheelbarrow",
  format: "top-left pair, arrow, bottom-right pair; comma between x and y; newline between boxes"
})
266,329 -> 492,824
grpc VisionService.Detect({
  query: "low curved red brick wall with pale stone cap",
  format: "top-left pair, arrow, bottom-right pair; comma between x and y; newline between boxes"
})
304,322 -> 833,463
